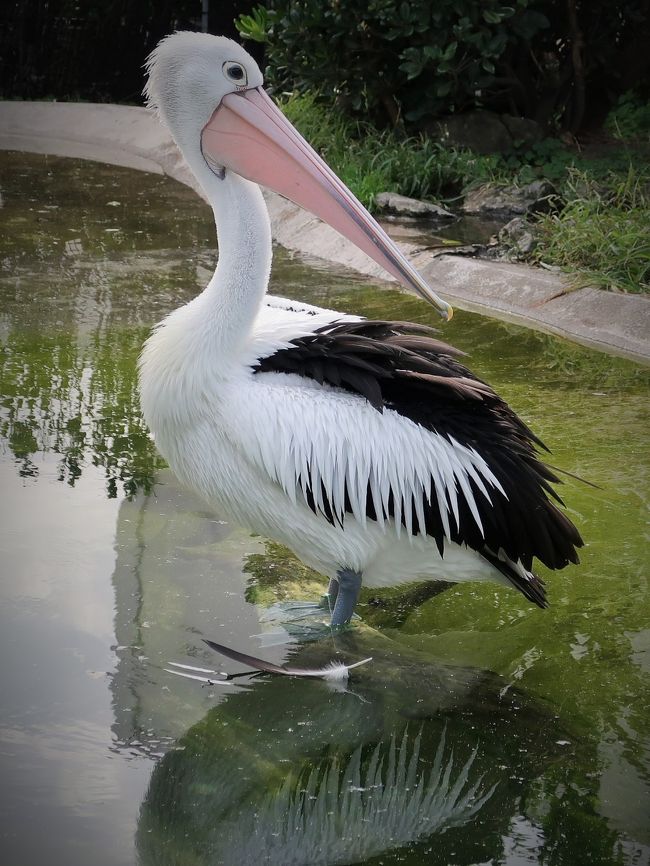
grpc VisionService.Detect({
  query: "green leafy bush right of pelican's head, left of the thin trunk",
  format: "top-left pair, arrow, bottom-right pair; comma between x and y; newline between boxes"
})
237,0 -> 548,125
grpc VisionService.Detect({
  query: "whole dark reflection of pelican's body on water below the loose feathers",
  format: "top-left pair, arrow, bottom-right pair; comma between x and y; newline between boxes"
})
137,632 -> 572,866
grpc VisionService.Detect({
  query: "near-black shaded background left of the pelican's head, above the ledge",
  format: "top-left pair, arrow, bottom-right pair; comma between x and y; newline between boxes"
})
0,0 -> 253,103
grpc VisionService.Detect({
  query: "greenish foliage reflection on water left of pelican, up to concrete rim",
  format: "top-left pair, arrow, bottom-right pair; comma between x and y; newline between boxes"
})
0,153 -> 212,497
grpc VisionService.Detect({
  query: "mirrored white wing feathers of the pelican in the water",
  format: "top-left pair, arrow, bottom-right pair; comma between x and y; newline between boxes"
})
215,729 -> 496,866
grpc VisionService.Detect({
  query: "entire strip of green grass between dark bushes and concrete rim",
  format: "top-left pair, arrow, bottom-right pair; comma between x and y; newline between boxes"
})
279,94 -> 650,292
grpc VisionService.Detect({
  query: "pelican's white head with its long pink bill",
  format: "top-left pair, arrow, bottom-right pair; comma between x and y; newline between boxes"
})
145,32 -> 452,319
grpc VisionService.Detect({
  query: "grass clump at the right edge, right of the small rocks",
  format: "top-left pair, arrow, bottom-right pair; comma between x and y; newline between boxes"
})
536,165 -> 650,292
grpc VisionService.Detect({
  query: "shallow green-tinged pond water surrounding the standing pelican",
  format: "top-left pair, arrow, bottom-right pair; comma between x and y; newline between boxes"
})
0,154 -> 650,866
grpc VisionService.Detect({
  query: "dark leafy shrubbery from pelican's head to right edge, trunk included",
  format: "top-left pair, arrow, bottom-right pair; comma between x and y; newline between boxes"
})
240,0 -> 650,132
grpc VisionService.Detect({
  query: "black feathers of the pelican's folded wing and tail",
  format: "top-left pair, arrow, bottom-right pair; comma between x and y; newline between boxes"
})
254,320 -> 583,606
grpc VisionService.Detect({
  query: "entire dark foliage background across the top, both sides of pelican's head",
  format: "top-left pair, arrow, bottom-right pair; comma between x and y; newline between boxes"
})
0,0 -> 650,132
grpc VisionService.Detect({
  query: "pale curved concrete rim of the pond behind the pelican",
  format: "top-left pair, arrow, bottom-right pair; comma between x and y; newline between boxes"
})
0,102 -> 650,363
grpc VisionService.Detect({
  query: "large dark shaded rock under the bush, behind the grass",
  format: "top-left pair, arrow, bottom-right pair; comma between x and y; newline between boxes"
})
425,111 -> 544,153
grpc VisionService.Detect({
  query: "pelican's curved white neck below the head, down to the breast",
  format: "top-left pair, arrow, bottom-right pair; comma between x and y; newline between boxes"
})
139,165 -> 271,436
